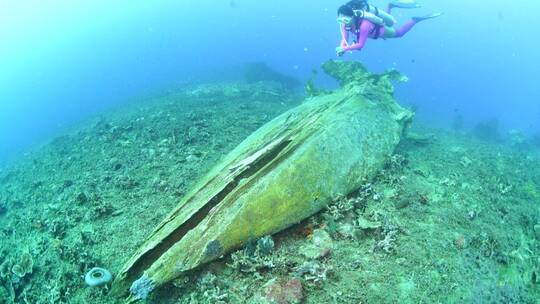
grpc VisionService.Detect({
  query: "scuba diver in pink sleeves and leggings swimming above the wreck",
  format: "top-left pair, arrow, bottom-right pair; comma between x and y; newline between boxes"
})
336,0 -> 442,56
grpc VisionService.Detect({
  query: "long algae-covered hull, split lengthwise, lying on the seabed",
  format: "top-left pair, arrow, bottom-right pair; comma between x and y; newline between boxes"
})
113,61 -> 412,298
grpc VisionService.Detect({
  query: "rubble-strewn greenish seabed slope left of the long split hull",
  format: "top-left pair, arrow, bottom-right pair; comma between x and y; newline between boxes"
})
0,82 -> 300,303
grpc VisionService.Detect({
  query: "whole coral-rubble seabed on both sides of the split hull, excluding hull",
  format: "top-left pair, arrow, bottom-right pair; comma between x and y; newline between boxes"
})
0,63 -> 540,304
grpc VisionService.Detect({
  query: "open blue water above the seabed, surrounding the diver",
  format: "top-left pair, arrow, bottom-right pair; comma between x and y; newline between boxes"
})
0,0 -> 540,165
